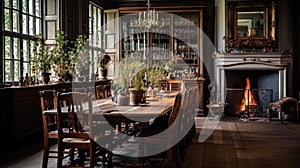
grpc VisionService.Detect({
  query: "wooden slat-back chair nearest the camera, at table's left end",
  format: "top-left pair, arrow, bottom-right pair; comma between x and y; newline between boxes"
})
56,92 -> 95,167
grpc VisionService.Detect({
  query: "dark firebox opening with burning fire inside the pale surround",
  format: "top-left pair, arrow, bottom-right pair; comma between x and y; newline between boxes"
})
224,75 -> 278,117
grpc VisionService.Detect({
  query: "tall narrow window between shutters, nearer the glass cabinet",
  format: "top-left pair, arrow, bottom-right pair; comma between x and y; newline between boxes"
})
89,3 -> 103,74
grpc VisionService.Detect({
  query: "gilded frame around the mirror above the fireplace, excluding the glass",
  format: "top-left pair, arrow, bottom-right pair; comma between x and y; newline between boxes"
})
225,0 -> 277,48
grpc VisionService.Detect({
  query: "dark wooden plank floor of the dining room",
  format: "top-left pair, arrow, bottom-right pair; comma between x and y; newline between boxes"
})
0,118 -> 300,168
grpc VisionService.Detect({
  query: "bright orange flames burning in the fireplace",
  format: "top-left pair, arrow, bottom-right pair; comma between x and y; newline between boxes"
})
240,78 -> 257,111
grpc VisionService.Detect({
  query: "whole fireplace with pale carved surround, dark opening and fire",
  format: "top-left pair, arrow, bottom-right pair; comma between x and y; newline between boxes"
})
213,53 -> 292,117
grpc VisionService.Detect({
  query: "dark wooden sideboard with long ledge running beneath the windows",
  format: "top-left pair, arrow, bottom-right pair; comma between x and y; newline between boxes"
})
0,80 -> 111,148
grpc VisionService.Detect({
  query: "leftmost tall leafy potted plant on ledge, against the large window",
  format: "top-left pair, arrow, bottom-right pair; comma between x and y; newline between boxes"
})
30,35 -> 52,84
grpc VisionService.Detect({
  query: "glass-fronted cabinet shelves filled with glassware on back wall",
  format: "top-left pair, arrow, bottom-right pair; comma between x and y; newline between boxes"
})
120,10 -> 201,70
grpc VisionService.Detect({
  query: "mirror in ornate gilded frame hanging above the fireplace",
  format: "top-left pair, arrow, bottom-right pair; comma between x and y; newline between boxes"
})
226,0 -> 277,49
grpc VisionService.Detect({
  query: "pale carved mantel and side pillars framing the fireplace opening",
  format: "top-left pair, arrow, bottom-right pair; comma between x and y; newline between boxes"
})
212,52 -> 292,102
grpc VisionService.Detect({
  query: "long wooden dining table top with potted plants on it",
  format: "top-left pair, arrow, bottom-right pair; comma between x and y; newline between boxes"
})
43,92 -> 178,130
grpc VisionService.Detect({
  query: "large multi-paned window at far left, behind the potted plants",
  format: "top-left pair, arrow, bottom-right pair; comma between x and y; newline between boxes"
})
1,0 -> 42,82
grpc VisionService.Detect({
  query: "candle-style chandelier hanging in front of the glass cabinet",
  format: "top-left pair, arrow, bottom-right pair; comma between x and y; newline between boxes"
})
138,0 -> 158,30
